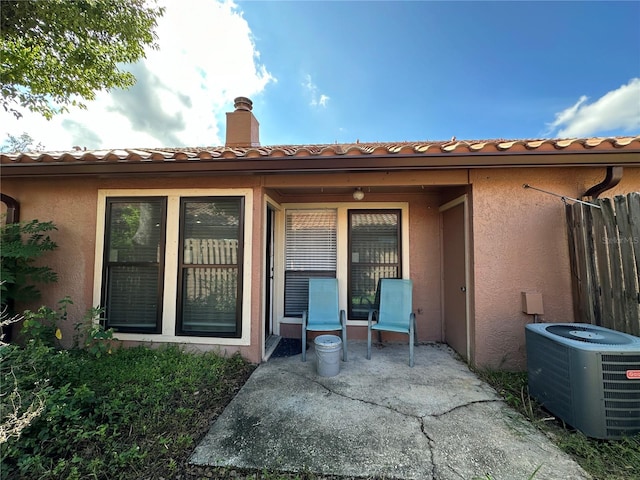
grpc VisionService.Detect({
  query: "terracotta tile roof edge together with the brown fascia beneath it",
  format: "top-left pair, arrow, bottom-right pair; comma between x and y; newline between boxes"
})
0,135 -> 640,178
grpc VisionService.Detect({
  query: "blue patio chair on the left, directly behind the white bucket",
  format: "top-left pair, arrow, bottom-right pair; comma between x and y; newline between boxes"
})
302,278 -> 347,362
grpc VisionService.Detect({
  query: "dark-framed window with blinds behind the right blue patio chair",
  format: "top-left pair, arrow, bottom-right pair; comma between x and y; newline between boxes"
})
348,210 -> 402,320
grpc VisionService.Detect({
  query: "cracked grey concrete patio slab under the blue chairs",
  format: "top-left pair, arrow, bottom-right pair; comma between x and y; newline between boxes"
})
190,342 -> 590,480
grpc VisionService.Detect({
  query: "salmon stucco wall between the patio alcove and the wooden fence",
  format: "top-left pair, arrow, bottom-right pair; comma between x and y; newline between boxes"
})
470,168 -> 640,370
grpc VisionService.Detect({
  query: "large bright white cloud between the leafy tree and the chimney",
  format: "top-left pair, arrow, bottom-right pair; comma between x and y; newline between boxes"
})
0,0 -> 276,150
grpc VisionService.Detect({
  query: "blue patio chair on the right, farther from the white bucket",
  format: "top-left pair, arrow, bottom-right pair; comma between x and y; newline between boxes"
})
367,278 -> 416,367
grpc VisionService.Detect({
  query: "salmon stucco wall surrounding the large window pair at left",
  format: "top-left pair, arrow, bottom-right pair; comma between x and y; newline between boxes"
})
2,177 -> 262,362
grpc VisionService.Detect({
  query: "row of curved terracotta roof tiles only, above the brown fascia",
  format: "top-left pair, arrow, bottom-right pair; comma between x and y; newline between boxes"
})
0,135 -> 640,166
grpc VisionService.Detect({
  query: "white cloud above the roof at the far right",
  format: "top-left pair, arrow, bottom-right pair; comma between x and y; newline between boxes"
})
546,78 -> 640,137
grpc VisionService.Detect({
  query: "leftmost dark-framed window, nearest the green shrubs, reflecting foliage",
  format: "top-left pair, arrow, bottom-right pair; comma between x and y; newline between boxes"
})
102,197 -> 166,333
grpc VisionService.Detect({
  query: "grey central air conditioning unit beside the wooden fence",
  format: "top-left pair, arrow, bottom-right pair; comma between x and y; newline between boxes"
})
525,323 -> 640,439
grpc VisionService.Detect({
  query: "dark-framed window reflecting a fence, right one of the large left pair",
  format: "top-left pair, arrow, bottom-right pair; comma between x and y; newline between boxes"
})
176,197 -> 244,337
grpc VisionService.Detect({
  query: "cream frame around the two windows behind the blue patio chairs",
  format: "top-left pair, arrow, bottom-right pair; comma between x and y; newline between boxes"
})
275,202 -> 411,326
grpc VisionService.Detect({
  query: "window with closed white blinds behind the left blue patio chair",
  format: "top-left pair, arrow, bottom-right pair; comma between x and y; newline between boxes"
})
284,209 -> 337,317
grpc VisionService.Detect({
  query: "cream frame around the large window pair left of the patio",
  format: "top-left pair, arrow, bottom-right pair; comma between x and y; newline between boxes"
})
93,188 -> 253,346
